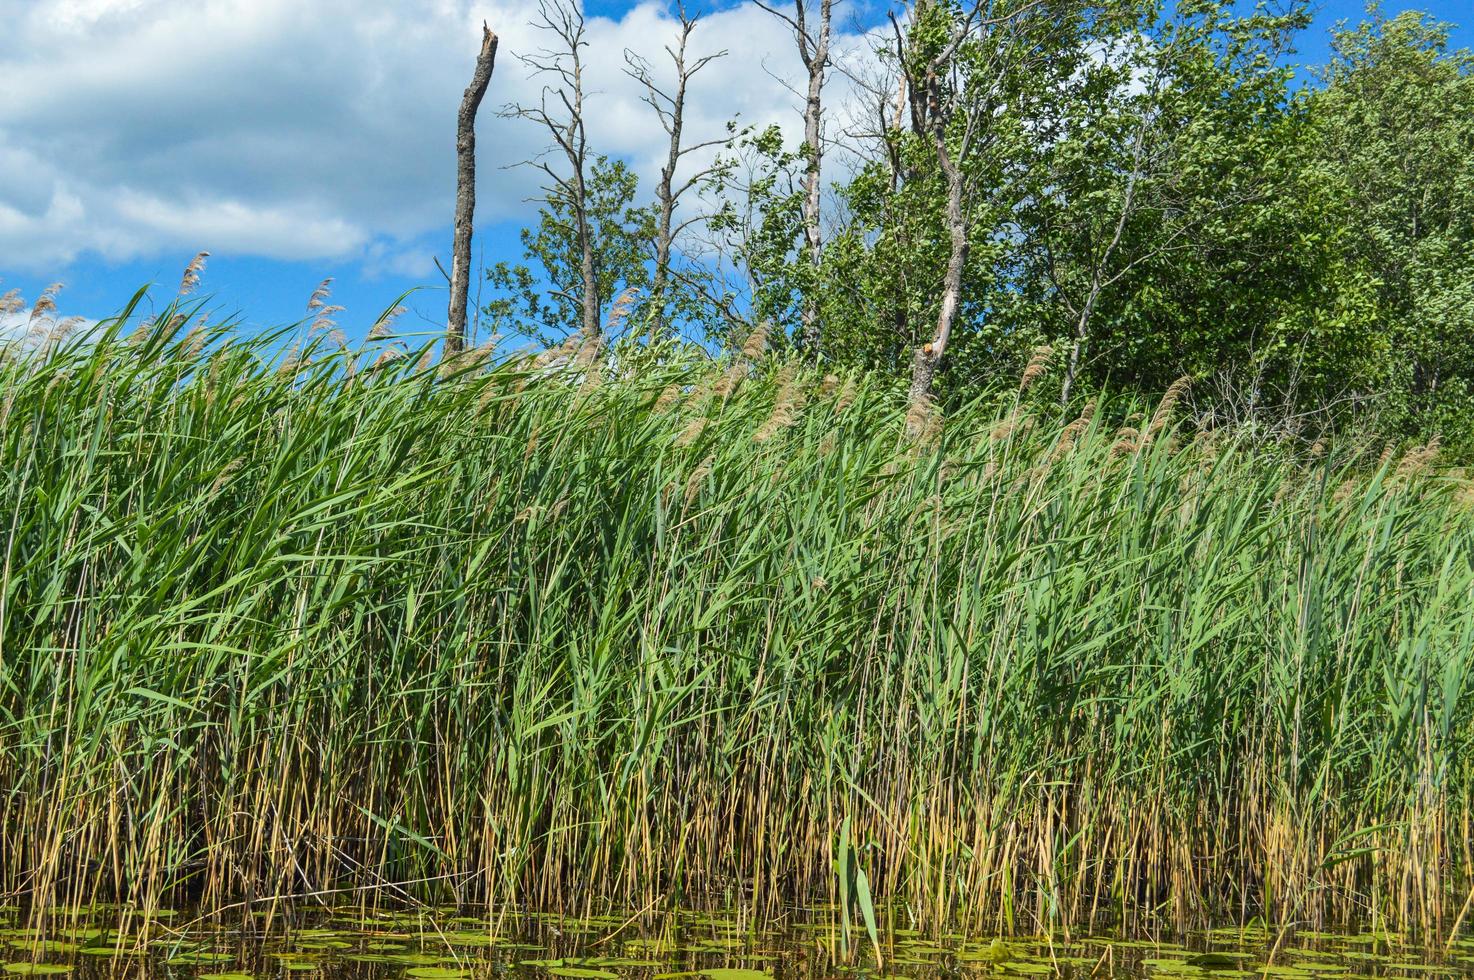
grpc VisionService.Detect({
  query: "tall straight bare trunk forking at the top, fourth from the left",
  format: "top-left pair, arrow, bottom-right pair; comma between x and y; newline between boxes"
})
755,0 -> 834,357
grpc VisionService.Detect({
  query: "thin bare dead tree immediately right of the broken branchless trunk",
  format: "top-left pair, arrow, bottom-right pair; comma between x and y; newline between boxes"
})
503,0 -> 601,342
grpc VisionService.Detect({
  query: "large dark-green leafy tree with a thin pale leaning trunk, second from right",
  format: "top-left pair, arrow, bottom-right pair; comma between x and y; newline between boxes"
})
1019,0 -> 1304,401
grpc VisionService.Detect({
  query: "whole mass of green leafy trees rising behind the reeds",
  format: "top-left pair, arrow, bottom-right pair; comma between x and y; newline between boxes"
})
489,0 -> 1474,455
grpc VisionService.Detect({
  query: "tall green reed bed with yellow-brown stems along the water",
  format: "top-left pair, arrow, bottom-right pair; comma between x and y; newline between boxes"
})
0,296 -> 1474,933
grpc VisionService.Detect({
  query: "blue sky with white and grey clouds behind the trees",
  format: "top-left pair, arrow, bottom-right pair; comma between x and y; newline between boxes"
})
0,0 -> 1474,340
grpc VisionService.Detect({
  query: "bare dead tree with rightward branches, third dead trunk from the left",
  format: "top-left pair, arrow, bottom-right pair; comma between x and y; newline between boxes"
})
625,4 -> 727,336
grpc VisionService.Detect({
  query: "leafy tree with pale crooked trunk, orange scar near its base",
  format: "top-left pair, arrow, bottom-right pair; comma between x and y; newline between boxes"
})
818,0 -> 1100,401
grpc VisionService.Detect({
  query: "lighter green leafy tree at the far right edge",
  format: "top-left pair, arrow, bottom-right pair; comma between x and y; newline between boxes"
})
1312,6 -> 1474,441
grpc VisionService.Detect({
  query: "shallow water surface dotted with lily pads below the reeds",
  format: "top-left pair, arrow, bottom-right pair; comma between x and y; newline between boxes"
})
0,906 -> 1474,980
